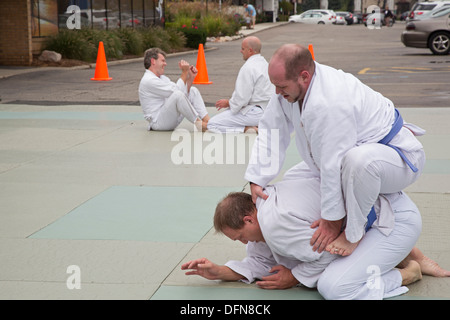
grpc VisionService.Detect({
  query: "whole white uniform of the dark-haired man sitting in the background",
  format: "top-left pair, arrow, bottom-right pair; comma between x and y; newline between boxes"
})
139,70 -> 208,130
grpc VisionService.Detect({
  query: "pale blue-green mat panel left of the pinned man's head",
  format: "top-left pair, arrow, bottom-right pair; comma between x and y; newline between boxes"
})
30,186 -> 236,242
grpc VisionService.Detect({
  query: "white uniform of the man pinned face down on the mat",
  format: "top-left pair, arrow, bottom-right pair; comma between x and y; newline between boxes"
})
225,178 -> 421,299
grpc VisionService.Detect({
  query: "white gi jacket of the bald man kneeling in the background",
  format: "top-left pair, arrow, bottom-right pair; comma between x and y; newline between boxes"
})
229,54 -> 275,114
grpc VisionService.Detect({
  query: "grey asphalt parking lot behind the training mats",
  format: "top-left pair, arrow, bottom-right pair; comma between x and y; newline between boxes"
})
0,22 -> 450,107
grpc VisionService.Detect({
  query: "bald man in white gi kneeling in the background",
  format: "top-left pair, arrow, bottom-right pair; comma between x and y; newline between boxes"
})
208,37 -> 275,133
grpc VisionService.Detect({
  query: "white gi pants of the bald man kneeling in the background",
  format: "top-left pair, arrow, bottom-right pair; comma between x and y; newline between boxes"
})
207,106 -> 264,133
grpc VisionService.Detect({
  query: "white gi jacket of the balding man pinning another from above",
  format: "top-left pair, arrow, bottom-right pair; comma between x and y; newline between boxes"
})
245,62 -> 423,220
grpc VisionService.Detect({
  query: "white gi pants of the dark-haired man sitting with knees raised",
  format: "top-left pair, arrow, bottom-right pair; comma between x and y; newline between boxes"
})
149,87 -> 208,130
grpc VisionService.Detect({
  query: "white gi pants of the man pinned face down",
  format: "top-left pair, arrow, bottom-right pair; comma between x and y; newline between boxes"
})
317,194 -> 422,300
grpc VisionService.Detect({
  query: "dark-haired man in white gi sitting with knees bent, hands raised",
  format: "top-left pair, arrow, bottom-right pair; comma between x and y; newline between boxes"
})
139,48 -> 209,131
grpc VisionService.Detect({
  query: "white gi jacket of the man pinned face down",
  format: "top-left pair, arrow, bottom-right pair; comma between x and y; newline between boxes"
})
225,178 -> 338,288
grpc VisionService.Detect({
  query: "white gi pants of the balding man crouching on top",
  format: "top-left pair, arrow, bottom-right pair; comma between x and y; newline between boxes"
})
283,143 -> 425,243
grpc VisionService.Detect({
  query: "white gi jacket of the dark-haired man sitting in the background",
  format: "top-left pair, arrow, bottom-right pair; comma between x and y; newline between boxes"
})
139,69 -> 187,122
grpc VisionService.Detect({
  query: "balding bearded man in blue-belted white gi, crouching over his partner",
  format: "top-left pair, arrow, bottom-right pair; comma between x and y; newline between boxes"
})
245,44 -> 425,255
